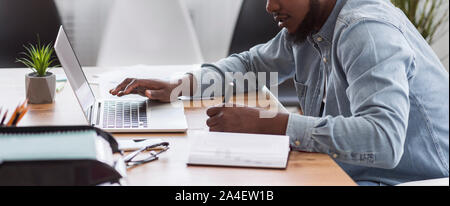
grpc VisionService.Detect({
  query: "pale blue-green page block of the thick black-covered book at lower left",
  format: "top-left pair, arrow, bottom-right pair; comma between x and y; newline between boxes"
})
0,130 -> 113,165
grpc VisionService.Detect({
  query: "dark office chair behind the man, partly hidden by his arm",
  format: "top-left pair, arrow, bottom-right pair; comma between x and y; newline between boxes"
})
229,0 -> 299,106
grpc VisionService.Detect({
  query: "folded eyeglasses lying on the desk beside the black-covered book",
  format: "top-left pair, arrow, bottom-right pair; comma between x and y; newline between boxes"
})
123,142 -> 169,168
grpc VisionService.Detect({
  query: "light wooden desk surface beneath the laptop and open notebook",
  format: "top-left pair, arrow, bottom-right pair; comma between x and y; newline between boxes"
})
0,68 -> 356,186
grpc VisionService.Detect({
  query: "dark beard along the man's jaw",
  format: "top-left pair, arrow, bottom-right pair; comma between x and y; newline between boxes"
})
292,0 -> 320,43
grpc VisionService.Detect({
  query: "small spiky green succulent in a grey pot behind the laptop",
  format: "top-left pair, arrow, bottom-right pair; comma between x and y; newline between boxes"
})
17,37 -> 56,104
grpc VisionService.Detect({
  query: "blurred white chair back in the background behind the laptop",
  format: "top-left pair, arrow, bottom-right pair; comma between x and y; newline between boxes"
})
97,0 -> 203,66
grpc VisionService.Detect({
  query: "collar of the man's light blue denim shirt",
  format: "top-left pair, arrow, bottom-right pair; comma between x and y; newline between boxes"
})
312,0 -> 347,42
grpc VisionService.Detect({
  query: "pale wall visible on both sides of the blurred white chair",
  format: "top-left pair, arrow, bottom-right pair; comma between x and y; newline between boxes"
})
55,0 -> 242,66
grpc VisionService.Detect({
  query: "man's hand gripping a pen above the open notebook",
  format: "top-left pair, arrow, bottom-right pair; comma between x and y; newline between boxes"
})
206,105 -> 289,135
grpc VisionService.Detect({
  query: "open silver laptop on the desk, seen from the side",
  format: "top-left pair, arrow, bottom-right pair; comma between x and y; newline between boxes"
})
55,26 -> 187,133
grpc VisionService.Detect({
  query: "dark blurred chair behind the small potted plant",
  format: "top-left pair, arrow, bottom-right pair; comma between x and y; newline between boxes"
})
0,0 -> 61,68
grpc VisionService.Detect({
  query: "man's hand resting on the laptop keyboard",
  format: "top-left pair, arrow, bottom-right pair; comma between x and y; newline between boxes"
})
109,78 -> 181,102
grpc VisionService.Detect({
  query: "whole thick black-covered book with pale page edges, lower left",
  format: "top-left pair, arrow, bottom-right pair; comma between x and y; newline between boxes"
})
0,126 -> 126,186
